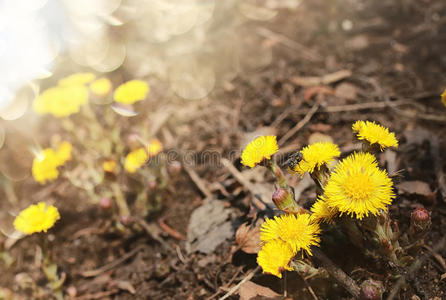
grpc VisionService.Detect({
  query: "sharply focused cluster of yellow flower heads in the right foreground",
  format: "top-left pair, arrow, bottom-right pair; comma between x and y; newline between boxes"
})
241,121 -> 398,277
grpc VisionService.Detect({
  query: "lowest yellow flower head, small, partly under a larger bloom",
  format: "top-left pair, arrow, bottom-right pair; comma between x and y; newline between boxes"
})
257,240 -> 294,278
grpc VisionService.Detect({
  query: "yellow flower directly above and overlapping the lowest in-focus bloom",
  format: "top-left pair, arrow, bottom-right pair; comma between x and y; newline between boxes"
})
260,214 -> 320,255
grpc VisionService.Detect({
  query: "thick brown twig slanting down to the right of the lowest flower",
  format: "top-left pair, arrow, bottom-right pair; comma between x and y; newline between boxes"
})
313,248 -> 360,299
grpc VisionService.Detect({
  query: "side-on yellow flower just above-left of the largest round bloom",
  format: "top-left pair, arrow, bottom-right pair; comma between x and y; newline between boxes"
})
293,142 -> 341,175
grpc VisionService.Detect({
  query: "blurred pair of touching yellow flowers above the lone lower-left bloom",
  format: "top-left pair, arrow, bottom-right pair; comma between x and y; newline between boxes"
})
31,141 -> 72,184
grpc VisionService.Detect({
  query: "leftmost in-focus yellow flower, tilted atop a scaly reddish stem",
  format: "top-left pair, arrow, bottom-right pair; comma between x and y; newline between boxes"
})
242,135 -> 279,168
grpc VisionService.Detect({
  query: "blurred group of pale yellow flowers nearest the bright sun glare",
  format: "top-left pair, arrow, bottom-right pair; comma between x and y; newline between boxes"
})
33,73 -> 149,118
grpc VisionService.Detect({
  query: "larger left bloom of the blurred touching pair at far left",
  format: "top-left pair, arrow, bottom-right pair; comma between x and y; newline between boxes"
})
31,148 -> 60,184
